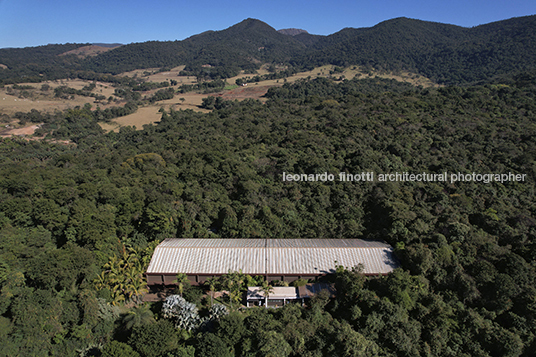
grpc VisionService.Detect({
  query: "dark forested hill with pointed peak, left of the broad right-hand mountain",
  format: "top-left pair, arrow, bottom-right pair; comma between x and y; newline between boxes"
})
85,19 -> 305,77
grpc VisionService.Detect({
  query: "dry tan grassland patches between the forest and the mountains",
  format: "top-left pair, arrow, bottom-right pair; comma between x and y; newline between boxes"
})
0,65 -> 437,135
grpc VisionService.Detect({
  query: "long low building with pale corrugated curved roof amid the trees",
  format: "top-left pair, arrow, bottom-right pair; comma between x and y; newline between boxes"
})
146,238 -> 399,285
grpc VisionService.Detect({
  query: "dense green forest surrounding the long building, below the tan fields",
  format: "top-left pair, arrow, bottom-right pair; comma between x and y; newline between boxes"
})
0,73 -> 536,357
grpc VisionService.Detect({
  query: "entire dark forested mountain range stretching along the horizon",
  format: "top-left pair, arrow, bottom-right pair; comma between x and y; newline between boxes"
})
0,15 -> 536,84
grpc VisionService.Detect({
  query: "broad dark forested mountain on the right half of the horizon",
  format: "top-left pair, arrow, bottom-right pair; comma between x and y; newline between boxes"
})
296,16 -> 536,84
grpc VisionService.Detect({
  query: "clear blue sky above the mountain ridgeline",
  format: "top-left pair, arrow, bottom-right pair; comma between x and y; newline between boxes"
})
0,0 -> 536,48
